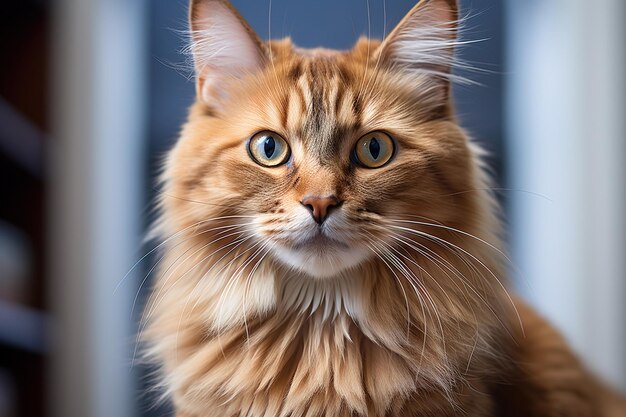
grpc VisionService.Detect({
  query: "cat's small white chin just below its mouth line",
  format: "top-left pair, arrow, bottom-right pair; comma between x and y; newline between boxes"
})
274,245 -> 369,279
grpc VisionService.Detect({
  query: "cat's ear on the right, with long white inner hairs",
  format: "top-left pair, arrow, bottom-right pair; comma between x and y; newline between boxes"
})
378,0 -> 459,91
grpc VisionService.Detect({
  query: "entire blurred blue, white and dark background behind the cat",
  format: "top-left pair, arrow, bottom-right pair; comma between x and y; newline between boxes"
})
0,0 -> 626,417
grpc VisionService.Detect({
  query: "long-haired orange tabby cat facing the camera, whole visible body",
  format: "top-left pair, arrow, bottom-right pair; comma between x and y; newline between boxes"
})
144,0 -> 626,417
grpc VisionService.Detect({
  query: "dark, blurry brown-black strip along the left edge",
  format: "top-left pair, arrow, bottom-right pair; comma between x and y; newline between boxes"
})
0,0 -> 50,417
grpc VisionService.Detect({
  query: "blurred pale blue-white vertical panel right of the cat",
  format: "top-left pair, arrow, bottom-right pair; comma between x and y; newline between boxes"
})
505,0 -> 626,389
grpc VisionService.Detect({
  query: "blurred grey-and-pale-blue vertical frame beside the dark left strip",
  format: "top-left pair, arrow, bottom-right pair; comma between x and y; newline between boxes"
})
48,0 -> 147,417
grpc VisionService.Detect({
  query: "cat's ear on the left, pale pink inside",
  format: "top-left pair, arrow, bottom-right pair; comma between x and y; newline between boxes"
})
189,0 -> 265,106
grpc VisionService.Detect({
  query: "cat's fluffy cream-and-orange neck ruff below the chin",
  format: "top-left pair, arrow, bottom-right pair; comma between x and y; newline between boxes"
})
147,247 -> 508,416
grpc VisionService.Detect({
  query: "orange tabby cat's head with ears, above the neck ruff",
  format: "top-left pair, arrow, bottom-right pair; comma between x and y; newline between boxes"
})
164,0 -> 482,278
